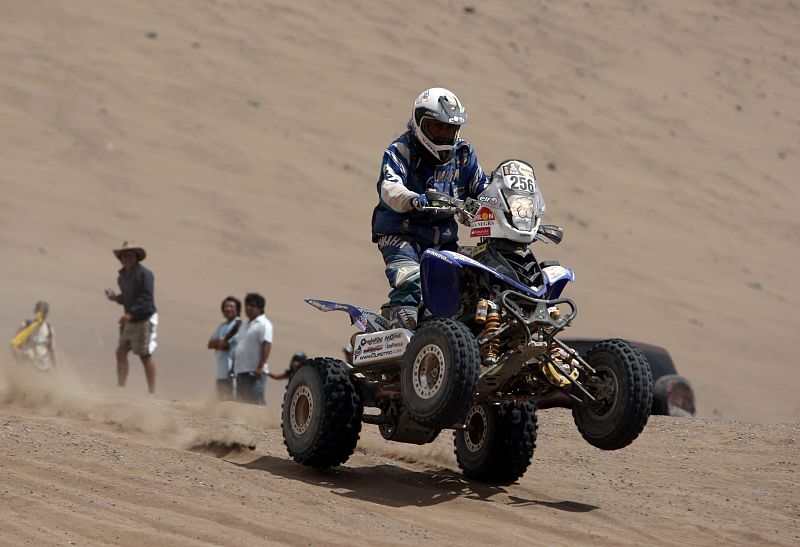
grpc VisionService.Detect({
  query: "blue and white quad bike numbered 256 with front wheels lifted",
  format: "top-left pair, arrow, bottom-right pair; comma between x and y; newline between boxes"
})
282,160 -> 653,483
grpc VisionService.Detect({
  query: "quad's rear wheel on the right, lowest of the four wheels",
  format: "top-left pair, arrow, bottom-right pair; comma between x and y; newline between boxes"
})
455,402 -> 537,484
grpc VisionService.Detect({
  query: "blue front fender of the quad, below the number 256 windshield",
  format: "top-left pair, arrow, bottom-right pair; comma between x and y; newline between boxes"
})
420,249 -> 575,317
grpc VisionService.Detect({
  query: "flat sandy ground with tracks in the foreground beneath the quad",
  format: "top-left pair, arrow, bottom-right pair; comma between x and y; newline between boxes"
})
0,366 -> 800,545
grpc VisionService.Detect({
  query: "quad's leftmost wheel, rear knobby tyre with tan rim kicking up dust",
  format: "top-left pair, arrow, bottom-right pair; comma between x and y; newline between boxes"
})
281,357 -> 364,468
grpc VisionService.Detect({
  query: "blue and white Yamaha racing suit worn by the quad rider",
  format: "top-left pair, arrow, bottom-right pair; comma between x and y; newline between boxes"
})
372,130 -> 488,306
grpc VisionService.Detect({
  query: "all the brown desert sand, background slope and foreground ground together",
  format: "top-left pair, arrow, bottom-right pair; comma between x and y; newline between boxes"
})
0,0 -> 800,545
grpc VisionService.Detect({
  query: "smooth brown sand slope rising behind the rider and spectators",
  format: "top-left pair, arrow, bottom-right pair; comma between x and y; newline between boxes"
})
0,2 -> 800,422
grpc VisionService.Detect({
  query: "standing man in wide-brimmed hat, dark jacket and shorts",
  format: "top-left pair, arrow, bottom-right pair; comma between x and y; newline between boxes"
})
106,241 -> 158,393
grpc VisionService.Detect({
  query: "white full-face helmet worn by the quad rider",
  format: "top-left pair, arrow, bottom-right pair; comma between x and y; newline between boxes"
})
411,87 -> 467,163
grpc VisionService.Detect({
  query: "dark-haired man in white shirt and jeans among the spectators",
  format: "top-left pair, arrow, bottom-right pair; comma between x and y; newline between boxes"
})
233,293 -> 272,405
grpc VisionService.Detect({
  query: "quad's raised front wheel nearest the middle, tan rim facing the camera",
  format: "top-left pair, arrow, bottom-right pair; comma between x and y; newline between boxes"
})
400,319 -> 480,429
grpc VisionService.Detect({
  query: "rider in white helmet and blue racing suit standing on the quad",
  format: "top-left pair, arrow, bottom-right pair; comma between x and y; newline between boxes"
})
372,87 -> 488,330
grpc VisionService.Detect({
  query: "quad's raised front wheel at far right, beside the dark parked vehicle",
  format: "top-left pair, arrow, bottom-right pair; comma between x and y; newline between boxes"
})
572,339 -> 653,450
